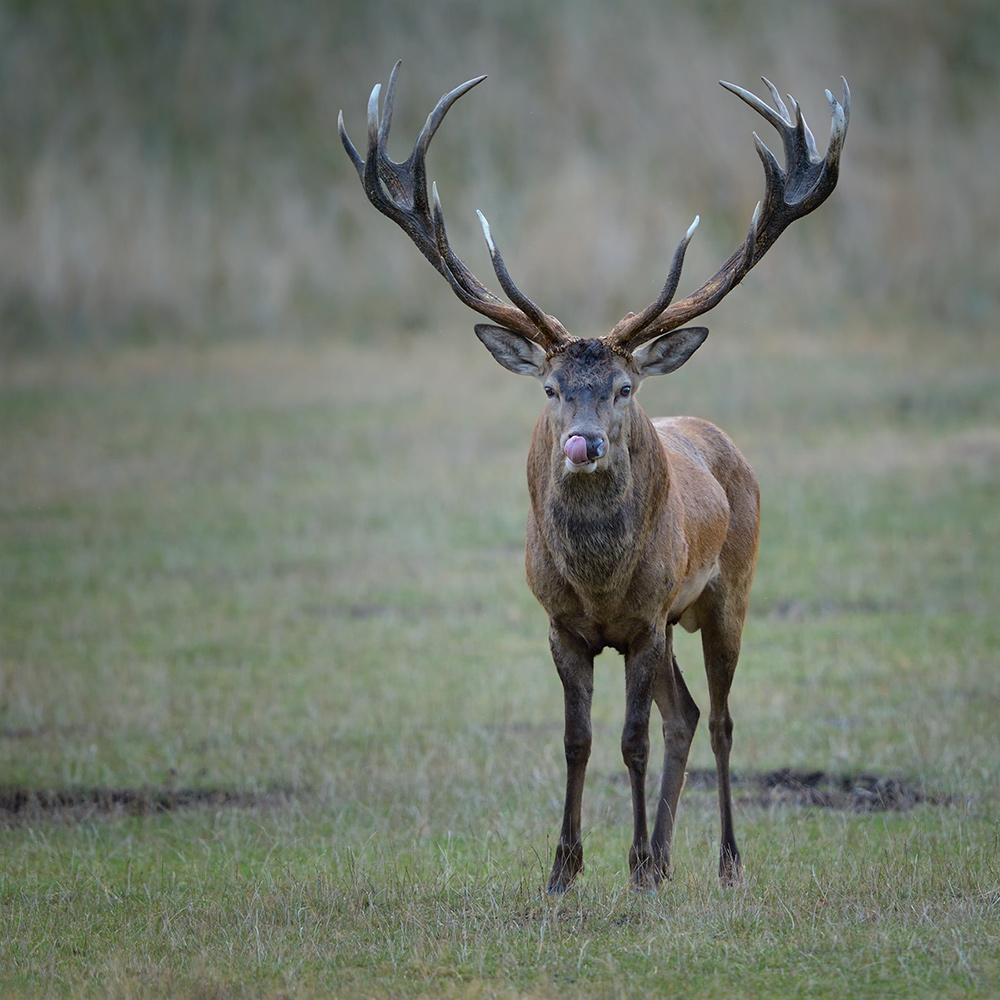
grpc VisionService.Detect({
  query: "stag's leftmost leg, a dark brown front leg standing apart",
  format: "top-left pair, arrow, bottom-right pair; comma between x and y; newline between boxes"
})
548,626 -> 594,892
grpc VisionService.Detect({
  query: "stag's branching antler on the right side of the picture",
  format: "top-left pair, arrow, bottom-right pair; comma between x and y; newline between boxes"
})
603,78 -> 851,350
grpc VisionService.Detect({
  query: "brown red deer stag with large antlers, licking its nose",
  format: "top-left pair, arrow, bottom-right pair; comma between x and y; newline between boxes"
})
338,63 -> 850,893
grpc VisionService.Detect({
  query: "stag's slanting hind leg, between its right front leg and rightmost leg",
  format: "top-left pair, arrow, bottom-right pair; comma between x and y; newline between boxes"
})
650,625 -> 701,879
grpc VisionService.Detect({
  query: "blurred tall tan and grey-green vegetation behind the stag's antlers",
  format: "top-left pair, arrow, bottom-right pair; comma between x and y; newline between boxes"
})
0,0 -> 1000,353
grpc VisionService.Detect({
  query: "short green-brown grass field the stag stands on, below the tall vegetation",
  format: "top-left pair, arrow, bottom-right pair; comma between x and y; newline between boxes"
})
0,324 -> 1000,998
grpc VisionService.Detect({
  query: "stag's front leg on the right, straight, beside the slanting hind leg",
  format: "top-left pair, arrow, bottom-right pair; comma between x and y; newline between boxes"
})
622,636 -> 665,891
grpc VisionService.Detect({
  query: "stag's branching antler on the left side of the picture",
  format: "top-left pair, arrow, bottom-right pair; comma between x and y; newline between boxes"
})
337,62 -> 571,350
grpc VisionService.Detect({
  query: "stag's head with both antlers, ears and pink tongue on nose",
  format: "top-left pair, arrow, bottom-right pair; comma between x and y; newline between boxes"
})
338,63 -> 850,472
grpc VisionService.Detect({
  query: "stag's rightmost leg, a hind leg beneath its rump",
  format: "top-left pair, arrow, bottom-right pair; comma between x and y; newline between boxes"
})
701,620 -> 742,885
